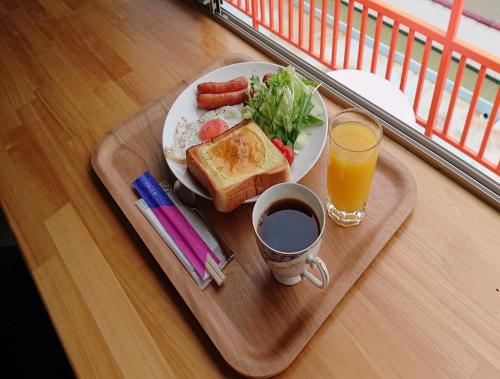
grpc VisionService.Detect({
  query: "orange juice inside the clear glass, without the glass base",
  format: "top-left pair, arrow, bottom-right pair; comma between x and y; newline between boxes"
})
327,121 -> 379,212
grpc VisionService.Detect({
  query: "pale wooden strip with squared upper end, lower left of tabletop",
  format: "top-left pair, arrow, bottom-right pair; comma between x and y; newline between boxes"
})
45,204 -> 173,378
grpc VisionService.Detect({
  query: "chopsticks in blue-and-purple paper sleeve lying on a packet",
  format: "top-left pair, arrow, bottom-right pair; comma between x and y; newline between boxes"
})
133,172 -> 227,289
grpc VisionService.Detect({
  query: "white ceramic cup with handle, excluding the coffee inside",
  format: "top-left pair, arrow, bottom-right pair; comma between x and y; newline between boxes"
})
252,183 -> 330,288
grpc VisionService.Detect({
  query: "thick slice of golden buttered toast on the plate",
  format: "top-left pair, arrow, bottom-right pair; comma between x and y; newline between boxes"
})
186,120 -> 290,212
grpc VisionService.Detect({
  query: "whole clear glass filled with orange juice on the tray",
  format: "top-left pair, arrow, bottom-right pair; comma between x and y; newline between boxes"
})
327,108 -> 382,226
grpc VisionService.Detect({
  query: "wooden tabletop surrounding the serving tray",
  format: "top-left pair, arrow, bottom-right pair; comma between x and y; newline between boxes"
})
0,0 -> 500,378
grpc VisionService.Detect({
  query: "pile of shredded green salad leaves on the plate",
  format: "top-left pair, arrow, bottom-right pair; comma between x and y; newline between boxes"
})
245,66 -> 323,148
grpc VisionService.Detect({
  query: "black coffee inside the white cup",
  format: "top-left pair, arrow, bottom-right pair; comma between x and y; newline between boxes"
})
257,199 -> 320,253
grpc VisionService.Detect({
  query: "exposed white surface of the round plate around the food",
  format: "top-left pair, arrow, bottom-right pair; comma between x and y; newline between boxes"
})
163,62 -> 328,202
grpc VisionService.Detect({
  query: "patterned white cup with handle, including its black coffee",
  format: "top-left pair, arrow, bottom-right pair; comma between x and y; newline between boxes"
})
252,183 -> 330,288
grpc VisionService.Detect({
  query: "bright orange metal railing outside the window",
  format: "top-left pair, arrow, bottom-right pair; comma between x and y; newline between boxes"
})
226,0 -> 500,175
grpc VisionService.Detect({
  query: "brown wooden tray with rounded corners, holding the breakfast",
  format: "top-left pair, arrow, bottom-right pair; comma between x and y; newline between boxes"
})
92,55 -> 416,377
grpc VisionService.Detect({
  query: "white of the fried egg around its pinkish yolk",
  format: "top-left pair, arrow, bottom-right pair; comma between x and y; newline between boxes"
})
165,105 -> 243,163
